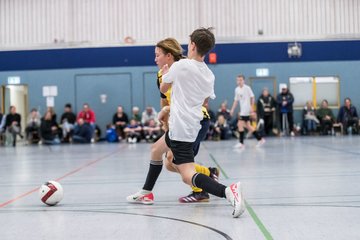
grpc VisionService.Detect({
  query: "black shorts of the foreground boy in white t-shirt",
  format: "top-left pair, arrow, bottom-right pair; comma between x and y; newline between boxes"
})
165,132 -> 194,165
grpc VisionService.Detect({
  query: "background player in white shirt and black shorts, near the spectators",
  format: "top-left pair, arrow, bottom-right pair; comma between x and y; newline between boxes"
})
230,75 -> 265,148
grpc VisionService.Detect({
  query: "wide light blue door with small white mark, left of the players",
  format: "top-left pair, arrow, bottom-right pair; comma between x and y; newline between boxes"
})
75,73 -> 132,136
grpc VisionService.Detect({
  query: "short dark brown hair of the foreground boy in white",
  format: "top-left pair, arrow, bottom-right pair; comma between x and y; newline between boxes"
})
190,28 -> 215,56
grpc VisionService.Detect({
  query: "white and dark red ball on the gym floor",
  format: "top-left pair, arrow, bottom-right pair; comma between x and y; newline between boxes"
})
39,181 -> 64,206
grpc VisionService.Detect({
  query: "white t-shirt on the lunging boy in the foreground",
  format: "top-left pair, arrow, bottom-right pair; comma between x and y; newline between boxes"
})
163,59 -> 215,142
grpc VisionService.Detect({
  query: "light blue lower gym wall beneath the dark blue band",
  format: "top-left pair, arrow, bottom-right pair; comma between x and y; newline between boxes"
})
0,61 -> 360,134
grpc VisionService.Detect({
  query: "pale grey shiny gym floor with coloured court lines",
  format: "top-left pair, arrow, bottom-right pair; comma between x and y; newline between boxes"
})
0,136 -> 360,240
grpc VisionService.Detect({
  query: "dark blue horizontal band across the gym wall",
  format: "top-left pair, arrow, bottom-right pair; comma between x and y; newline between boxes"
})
0,41 -> 360,71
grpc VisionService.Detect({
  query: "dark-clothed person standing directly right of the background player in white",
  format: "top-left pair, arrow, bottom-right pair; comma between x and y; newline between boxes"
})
257,88 -> 276,135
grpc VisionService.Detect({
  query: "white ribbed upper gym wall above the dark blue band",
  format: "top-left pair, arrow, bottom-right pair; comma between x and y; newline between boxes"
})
0,0 -> 360,49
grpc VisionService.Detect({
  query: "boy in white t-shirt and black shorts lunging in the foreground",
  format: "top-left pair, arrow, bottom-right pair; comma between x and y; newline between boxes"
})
159,28 -> 245,217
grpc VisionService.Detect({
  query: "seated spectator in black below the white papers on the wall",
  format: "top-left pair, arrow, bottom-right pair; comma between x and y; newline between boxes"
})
40,111 -> 61,145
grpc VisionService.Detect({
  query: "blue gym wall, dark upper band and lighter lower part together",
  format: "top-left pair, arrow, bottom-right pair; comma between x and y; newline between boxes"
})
0,41 -> 360,133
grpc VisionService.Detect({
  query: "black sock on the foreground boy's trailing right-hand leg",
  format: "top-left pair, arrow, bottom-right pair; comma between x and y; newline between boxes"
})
191,173 -> 226,198
